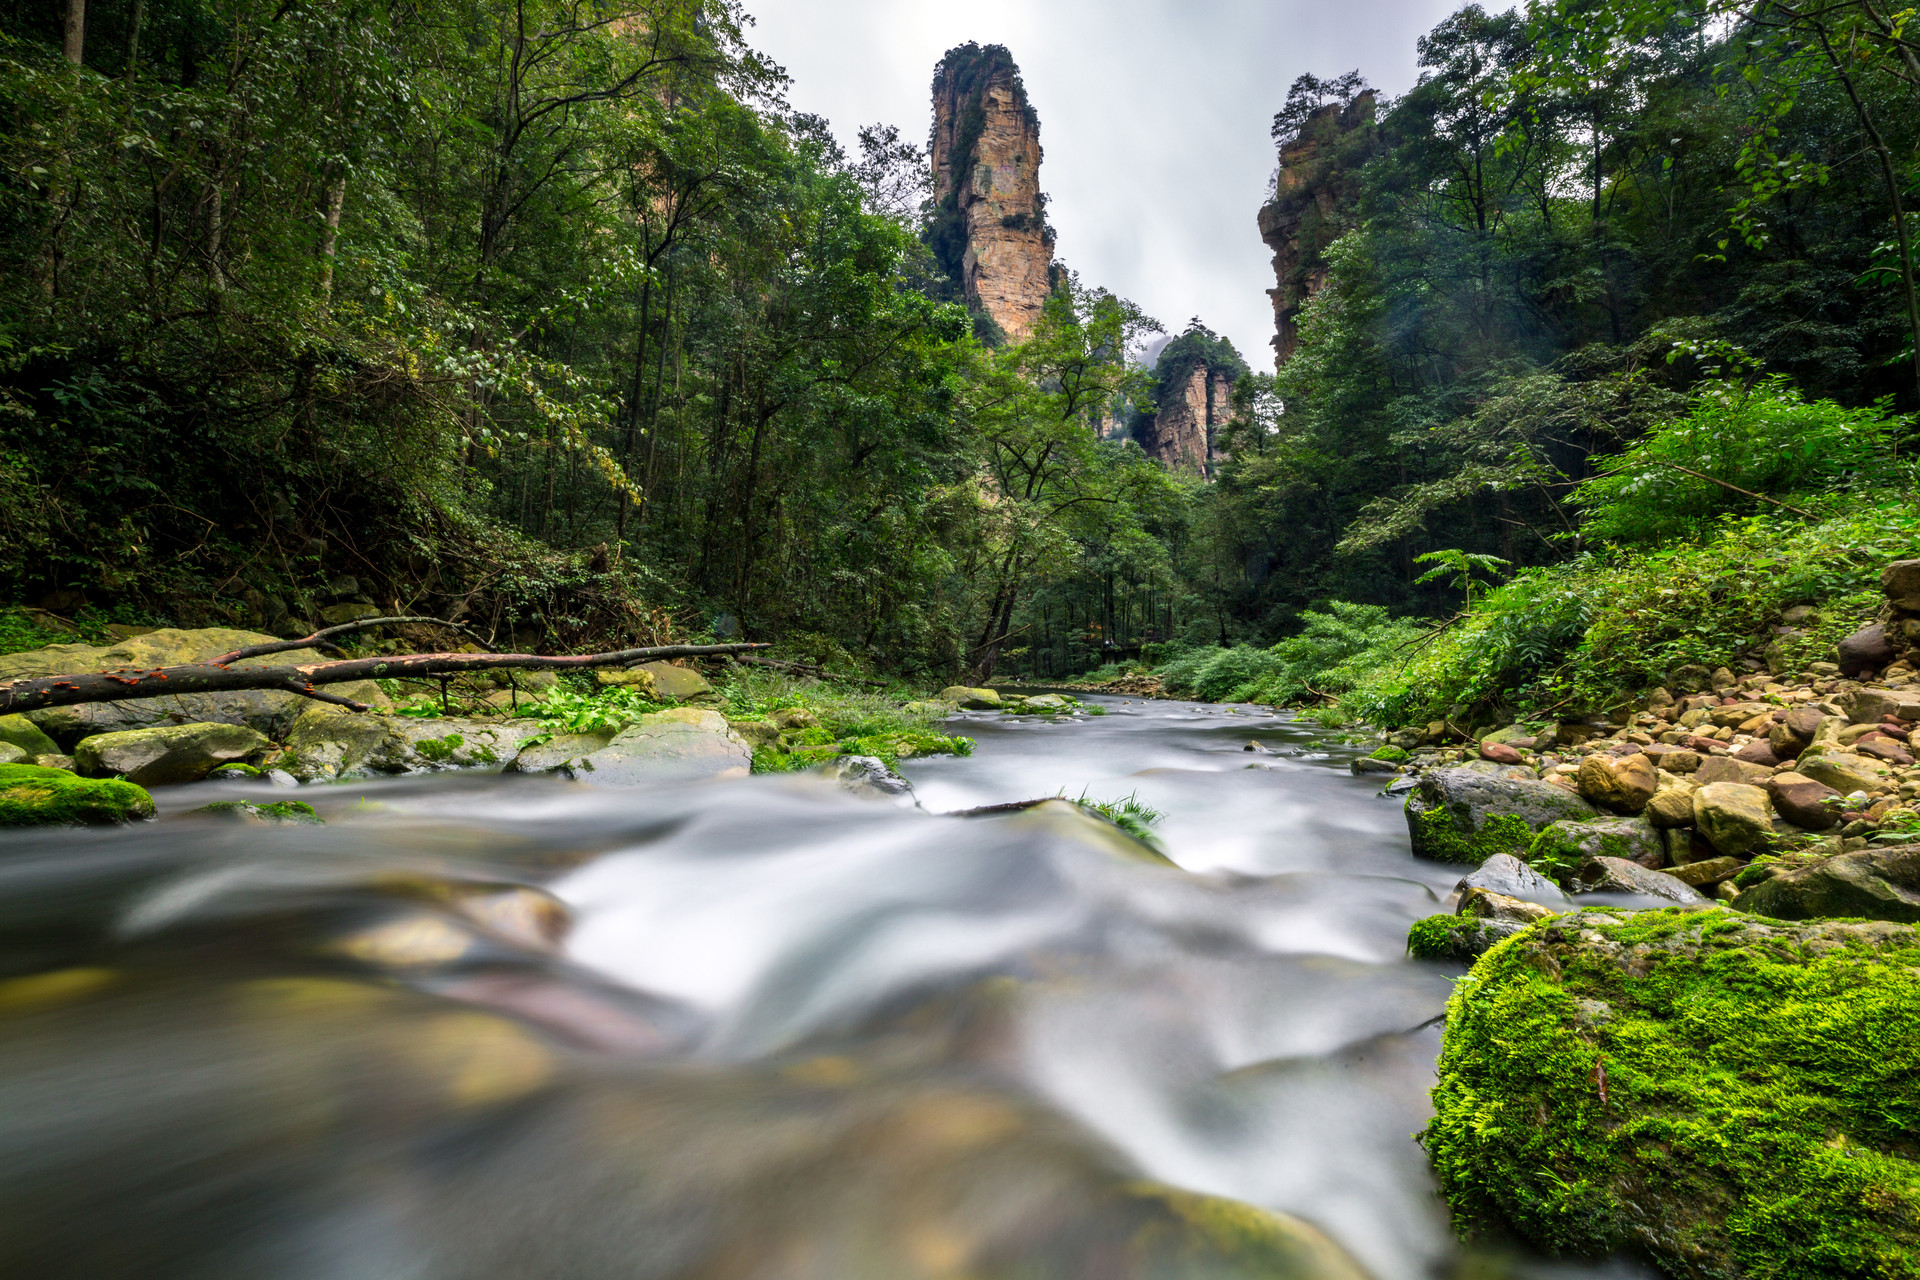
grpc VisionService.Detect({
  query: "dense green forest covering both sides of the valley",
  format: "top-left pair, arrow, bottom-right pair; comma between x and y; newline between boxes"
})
0,0 -> 1920,722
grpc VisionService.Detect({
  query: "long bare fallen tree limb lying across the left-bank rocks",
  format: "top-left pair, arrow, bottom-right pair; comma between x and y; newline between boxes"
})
0,640 -> 766,716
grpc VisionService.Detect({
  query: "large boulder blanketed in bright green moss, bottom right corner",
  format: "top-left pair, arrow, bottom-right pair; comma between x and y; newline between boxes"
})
1421,908 -> 1920,1280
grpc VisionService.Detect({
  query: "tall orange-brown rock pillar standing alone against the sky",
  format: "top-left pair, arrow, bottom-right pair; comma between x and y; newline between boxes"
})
929,44 -> 1054,342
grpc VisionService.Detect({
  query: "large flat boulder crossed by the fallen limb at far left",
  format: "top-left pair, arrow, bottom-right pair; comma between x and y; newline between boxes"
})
0,628 -> 388,745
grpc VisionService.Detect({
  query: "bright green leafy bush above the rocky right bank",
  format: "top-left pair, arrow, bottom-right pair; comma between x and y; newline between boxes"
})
1572,376 -> 1914,541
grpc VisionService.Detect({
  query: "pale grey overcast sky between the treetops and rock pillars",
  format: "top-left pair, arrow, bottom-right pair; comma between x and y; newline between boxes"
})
747,0 -> 1459,370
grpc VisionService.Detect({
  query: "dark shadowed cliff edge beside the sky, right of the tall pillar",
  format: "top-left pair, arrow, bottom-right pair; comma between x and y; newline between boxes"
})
1260,88 -> 1375,368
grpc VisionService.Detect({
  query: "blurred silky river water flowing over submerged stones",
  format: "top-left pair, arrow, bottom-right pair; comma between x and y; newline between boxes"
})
0,699 -> 1644,1280
